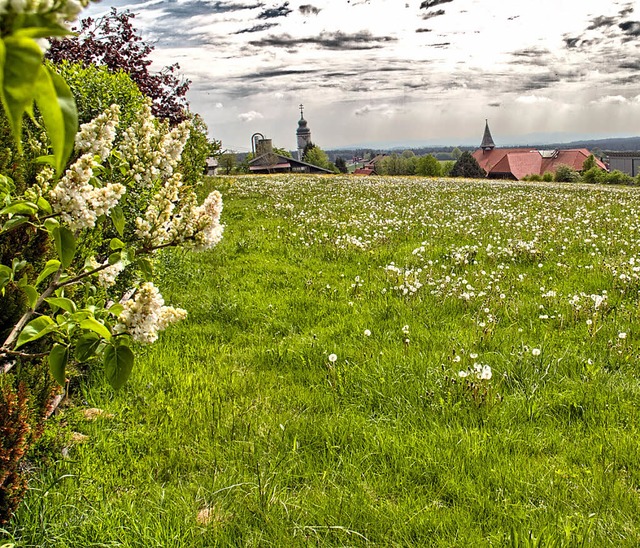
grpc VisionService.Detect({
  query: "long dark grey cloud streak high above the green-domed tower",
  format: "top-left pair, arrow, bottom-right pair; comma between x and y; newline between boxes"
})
249,31 -> 396,50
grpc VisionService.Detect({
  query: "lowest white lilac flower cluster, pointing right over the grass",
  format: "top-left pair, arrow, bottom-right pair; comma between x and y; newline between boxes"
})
115,282 -> 187,344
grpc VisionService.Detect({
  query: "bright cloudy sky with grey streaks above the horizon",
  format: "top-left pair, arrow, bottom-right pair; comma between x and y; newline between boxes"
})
88,0 -> 640,151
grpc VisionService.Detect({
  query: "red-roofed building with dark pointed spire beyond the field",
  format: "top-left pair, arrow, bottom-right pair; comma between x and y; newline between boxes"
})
473,121 -> 607,180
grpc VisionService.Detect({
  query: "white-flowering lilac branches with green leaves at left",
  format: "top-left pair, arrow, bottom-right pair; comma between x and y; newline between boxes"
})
0,102 -> 222,388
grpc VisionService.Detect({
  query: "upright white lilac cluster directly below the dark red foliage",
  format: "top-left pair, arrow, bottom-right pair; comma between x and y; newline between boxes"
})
118,100 -> 189,188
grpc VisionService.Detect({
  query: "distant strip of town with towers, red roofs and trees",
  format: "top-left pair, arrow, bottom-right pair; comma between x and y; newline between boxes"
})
208,105 -> 640,183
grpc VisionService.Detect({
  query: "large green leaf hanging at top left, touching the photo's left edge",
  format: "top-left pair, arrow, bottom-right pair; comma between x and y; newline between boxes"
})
0,36 -> 43,146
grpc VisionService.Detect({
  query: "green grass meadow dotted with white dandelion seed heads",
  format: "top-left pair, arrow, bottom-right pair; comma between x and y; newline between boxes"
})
0,175 -> 640,547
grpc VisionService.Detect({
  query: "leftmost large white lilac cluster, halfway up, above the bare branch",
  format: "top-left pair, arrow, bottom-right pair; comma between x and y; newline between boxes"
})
49,154 -> 126,230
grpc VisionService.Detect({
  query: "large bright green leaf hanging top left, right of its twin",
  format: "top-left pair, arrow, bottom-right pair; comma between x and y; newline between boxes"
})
34,66 -> 78,174
